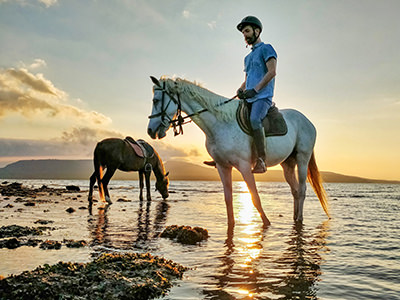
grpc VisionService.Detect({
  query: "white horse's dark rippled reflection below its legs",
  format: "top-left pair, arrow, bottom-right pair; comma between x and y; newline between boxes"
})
203,221 -> 329,299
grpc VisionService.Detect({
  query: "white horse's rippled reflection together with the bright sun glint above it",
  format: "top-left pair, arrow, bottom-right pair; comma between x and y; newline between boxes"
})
204,184 -> 329,299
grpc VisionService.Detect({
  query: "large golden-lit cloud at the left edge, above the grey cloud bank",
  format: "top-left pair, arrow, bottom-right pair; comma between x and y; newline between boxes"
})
0,65 -> 111,125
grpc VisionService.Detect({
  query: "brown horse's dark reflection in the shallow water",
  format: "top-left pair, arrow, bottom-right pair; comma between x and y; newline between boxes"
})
88,199 -> 169,251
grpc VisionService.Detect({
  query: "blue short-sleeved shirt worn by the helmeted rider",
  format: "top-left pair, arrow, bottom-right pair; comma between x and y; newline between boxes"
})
244,42 -> 277,103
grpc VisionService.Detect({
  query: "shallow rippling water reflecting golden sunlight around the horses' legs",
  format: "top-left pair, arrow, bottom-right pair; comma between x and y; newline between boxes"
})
0,180 -> 400,300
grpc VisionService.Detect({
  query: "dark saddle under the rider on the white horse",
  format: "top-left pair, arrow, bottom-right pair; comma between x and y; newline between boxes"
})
236,101 -> 287,136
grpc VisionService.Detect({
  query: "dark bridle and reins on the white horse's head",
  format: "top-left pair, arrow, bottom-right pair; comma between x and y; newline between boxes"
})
149,76 -> 237,136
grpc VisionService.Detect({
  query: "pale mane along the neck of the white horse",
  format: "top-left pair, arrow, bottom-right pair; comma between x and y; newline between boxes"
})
161,77 -> 238,121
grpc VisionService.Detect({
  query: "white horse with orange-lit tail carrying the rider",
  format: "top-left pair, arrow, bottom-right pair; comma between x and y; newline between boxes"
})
147,77 -> 329,228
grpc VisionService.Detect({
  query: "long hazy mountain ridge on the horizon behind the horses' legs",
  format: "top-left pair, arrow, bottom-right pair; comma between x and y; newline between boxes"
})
0,159 -> 400,183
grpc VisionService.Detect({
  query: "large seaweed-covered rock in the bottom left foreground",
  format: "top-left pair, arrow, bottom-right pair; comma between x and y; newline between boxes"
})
0,253 -> 186,300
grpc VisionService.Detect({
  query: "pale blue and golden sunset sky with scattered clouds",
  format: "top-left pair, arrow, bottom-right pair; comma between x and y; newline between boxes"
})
0,0 -> 400,180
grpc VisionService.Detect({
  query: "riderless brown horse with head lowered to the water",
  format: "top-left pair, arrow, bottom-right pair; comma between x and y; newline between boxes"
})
88,138 -> 169,206
